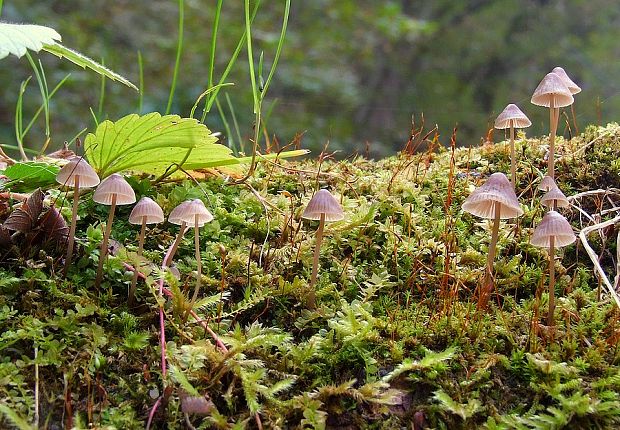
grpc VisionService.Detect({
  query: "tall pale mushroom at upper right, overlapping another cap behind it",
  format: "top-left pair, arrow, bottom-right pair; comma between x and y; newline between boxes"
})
531,73 -> 574,178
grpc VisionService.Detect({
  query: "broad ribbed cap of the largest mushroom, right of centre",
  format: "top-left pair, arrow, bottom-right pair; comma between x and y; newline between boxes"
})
462,172 -> 523,219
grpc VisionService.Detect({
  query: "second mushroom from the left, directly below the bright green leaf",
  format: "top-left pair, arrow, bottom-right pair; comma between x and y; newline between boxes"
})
93,173 -> 136,287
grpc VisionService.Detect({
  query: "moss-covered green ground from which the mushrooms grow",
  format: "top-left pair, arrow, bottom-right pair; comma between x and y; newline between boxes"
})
0,124 -> 620,429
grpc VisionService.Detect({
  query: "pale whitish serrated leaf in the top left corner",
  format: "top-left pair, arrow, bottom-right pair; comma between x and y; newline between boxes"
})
0,22 -> 61,59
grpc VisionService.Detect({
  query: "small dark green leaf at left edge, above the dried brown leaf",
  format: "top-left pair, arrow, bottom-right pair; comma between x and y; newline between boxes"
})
3,161 -> 60,192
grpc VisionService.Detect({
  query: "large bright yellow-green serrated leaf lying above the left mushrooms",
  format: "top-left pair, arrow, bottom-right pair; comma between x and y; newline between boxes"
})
84,112 -> 238,178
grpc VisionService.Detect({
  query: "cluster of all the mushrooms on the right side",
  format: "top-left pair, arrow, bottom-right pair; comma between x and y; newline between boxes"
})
462,67 -> 581,326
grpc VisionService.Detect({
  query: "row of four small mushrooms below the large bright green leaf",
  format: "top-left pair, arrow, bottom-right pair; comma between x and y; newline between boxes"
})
56,157 -> 213,305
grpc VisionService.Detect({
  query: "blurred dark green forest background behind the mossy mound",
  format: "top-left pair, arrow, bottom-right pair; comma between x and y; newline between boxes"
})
0,0 -> 620,157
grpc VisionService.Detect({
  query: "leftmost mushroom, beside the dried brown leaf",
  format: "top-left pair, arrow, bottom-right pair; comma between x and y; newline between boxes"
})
56,157 -> 99,276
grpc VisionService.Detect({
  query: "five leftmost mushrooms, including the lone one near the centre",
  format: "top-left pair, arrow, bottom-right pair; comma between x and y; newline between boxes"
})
56,157 -> 344,309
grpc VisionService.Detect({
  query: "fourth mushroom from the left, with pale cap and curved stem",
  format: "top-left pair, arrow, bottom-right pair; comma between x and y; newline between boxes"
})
168,199 -> 213,312
